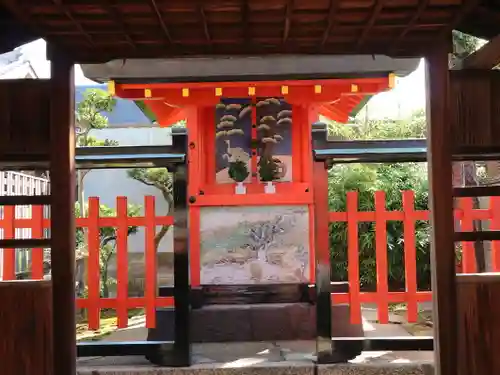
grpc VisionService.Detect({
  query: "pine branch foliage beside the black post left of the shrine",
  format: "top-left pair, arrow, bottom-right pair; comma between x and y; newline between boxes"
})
127,168 -> 174,250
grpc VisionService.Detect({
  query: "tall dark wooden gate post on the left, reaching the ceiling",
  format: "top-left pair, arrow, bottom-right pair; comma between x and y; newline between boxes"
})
50,46 -> 76,375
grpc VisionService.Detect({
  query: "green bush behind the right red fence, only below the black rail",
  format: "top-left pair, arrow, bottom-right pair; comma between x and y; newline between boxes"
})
328,163 -> 430,290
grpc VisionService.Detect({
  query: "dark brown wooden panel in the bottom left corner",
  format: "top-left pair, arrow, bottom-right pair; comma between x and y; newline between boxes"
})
0,281 -> 53,375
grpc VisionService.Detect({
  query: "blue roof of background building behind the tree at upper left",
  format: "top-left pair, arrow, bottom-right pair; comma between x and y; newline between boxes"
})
75,85 -> 151,127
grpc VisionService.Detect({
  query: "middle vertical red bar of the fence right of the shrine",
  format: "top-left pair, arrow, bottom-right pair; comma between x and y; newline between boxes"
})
375,191 -> 389,324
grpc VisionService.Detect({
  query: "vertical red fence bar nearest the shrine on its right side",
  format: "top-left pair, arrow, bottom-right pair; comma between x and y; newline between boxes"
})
347,191 -> 361,324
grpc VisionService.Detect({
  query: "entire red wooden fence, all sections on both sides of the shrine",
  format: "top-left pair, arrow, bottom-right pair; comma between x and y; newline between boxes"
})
0,191 -> 500,329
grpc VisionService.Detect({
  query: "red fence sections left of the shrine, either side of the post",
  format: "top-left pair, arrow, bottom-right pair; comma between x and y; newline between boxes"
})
0,196 -> 173,329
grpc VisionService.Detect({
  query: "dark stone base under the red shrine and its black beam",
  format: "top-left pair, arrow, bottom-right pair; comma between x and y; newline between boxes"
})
148,303 -> 364,364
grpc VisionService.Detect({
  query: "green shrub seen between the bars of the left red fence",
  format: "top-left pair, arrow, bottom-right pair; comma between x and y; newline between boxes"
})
75,203 -> 141,298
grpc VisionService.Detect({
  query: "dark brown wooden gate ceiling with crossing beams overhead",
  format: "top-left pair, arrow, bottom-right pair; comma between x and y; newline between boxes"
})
0,0 -> 500,62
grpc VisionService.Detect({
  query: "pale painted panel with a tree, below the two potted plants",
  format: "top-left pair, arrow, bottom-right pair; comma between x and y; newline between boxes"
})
200,206 -> 310,285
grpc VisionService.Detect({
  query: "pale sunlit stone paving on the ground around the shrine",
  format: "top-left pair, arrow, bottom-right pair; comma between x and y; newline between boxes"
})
79,304 -> 433,375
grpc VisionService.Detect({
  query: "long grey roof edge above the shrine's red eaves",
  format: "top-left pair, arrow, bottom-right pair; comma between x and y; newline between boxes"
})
82,55 -> 420,83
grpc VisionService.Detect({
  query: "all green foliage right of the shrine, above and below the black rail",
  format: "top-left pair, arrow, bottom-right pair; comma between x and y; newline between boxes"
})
328,111 -> 430,289
